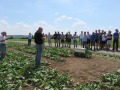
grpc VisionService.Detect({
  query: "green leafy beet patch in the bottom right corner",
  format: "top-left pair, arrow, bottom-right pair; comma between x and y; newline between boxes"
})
75,71 -> 120,90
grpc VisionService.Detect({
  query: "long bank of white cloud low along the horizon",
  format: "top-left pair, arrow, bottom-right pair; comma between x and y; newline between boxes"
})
0,15 -> 117,35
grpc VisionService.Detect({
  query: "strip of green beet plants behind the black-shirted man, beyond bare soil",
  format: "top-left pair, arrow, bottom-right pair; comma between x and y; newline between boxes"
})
8,43 -> 73,61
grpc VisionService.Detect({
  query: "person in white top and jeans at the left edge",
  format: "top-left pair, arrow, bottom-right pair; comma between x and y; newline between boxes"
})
0,32 -> 7,60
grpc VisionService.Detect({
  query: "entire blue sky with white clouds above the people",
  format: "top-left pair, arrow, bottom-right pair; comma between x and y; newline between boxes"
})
0,0 -> 120,35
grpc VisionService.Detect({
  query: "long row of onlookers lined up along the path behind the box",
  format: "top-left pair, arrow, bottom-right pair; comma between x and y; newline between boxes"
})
47,29 -> 119,51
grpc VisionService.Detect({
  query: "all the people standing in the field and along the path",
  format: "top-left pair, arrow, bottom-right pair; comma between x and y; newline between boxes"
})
0,27 -> 119,67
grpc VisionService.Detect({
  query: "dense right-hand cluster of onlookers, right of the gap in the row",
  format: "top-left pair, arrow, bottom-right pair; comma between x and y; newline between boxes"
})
80,29 -> 119,51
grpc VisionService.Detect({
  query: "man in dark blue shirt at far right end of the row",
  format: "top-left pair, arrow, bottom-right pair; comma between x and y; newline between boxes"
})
113,29 -> 119,51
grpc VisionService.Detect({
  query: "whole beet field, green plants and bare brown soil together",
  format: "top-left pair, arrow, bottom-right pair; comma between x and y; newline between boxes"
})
0,42 -> 120,90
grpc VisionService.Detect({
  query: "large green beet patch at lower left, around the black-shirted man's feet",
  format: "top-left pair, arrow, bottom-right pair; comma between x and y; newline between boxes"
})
0,51 -> 71,90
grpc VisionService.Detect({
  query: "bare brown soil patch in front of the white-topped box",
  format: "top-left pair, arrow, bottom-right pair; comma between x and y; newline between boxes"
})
44,56 -> 120,84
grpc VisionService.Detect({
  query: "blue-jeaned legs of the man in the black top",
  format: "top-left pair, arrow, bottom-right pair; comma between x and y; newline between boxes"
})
35,44 -> 42,67
